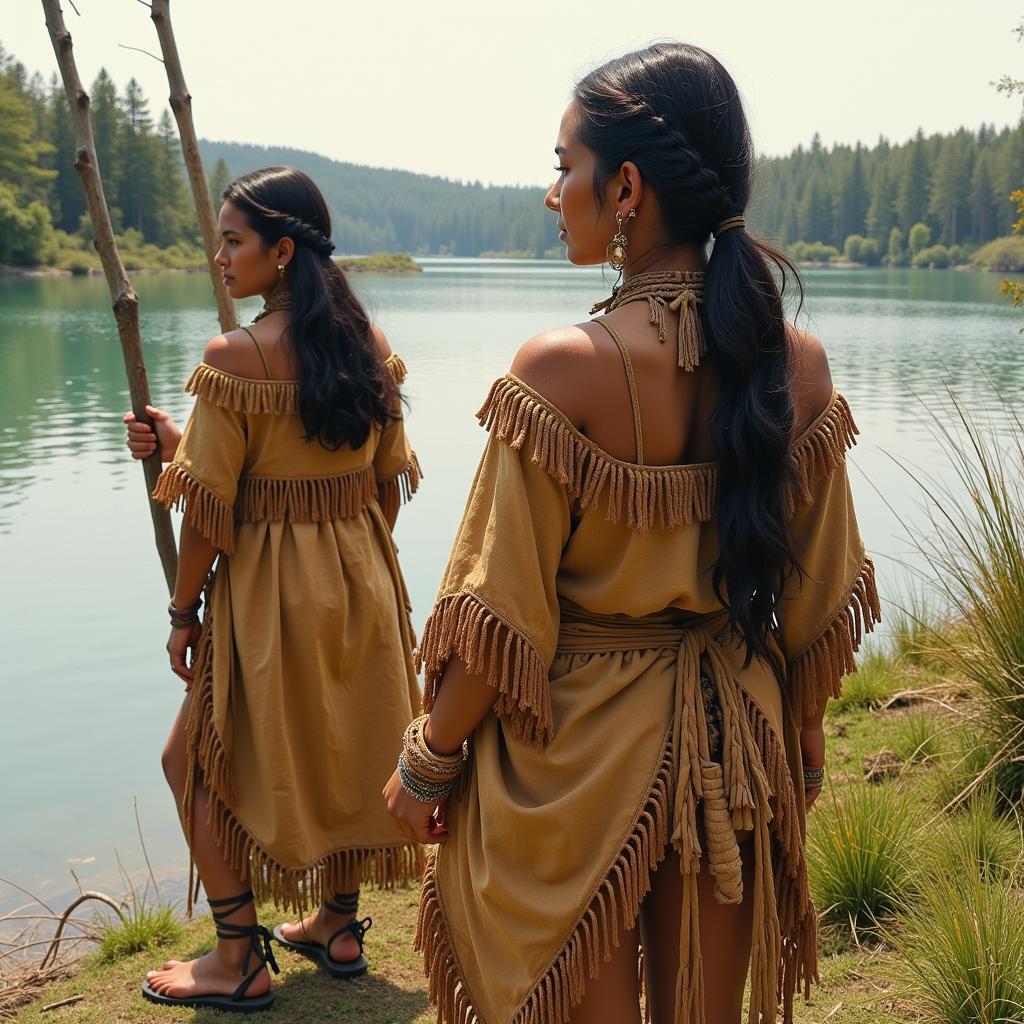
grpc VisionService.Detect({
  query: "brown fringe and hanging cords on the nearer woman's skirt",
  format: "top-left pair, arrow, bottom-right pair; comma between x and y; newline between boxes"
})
416,637 -> 818,1024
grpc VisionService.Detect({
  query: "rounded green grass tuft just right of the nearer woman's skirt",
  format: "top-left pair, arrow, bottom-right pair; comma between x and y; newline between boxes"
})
807,782 -> 924,934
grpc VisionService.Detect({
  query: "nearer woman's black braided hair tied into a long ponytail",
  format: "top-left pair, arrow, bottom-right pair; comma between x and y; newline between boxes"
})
573,43 -> 803,663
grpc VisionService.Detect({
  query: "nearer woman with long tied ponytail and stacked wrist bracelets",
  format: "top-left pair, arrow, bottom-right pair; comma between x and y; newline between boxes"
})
385,43 -> 879,1024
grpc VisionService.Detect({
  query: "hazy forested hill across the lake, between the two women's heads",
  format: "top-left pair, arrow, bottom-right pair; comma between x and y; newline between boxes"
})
200,139 -> 558,256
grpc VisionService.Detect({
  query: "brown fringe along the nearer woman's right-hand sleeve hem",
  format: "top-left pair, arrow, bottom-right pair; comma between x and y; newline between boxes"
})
788,555 -> 882,721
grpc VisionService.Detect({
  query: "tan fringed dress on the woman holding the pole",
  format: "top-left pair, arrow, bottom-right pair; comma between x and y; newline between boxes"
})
154,355 -> 422,907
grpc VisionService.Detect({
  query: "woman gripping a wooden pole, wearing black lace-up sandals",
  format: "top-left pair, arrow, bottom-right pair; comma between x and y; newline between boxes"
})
127,167 -> 422,1013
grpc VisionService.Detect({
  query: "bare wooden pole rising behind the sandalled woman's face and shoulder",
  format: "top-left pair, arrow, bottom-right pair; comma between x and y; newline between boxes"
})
147,0 -> 239,334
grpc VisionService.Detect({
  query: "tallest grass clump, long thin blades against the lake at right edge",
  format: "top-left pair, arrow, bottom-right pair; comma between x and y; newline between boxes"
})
908,391 -> 1024,804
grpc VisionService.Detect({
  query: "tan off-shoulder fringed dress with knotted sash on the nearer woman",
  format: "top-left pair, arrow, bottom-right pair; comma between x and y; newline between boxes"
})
417,333 -> 880,1024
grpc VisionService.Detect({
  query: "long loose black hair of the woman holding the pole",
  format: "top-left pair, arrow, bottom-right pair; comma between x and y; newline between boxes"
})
221,167 -> 395,451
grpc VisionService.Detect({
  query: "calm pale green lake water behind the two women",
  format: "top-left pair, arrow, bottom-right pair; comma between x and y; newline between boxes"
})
0,259 -> 1024,912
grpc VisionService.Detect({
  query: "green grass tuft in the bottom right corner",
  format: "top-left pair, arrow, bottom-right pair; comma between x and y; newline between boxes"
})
886,871 -> 1024,1024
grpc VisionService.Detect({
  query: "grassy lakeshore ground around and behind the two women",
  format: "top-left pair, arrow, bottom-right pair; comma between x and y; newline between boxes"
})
16,638 -> 1021,1024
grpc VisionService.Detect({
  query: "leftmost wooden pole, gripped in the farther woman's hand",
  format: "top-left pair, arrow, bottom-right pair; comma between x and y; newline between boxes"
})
42,0 -> 178,593
